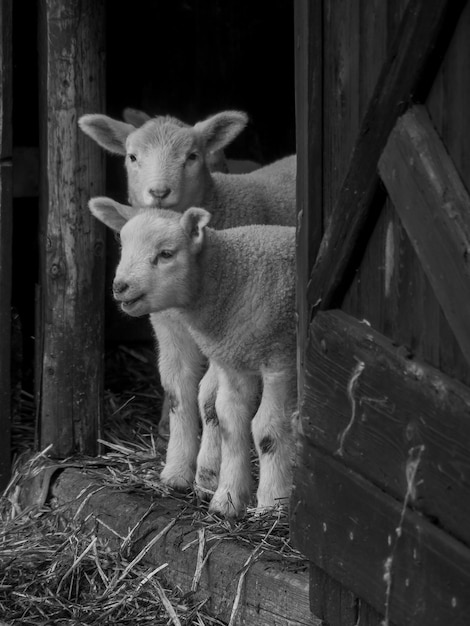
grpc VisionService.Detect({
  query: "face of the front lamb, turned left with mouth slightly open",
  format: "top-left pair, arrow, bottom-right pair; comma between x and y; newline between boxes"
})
113,211 -> 194,317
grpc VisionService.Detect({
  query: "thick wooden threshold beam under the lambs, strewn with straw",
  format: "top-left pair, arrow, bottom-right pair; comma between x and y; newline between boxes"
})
51,469 -> 321,626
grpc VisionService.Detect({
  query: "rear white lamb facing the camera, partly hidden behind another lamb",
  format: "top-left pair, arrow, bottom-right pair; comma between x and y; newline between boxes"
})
79,111 -> 296,491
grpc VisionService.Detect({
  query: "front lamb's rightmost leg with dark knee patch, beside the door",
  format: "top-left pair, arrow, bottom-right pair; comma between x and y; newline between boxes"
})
252,371 -> 296,508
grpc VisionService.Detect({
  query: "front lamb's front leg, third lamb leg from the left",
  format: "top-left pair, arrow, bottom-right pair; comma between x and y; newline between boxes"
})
209,365 -> 258,517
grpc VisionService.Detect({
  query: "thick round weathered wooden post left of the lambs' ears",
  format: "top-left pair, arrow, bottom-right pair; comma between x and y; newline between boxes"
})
36,0 -> 105,457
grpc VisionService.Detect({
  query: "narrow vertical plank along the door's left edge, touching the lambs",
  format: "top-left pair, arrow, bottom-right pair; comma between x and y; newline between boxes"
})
294,0 -> 323,394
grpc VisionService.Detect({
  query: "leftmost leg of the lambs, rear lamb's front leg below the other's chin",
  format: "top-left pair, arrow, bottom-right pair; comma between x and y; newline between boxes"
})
150,313 -> 206,489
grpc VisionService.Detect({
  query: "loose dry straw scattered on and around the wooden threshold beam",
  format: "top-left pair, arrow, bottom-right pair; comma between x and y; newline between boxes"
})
0,346 -> 307,626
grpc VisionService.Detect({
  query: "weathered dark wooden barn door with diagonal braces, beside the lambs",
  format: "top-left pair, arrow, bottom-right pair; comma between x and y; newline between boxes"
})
292,0 -> 470,626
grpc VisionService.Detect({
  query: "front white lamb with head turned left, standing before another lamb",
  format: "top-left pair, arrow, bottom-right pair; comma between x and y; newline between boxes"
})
90,198 -> 296,517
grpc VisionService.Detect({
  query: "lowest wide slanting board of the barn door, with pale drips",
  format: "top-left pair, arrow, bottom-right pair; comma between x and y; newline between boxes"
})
293,439 -> 470,626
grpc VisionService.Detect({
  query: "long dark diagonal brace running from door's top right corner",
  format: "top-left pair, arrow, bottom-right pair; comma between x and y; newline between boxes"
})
307,0 -> 465,318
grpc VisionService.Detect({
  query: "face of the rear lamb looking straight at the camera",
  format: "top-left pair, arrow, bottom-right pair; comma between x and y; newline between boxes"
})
126,118 -> 207,212
